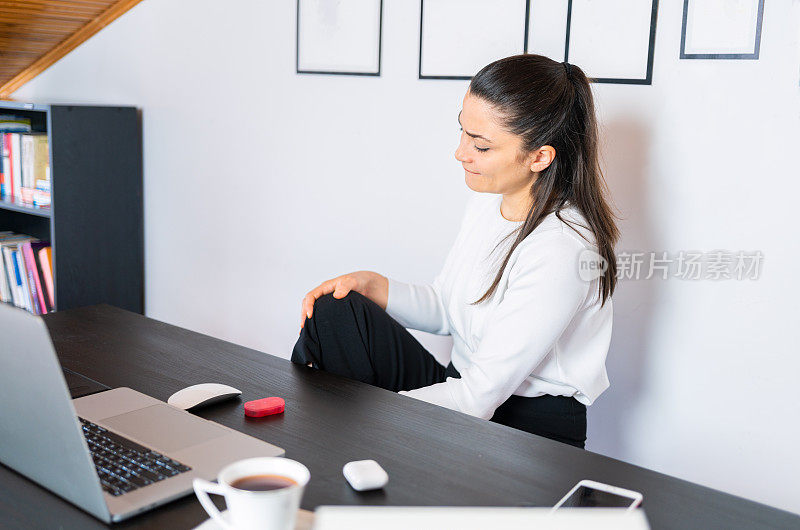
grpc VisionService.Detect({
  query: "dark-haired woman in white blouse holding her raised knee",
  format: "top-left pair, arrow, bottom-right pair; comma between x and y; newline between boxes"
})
292,54 -> 619,448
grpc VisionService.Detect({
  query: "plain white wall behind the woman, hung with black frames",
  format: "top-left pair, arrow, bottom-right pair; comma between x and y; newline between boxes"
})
14,0 -> 800,512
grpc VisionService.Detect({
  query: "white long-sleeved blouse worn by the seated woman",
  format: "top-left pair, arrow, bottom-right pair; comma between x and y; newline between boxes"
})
386,193 -> 612,419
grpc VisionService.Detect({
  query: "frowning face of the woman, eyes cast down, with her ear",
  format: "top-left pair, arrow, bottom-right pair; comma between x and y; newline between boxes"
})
455,91 -> 555,196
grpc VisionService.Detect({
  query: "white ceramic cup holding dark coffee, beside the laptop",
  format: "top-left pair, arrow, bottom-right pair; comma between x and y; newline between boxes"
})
192,457 -> 311,530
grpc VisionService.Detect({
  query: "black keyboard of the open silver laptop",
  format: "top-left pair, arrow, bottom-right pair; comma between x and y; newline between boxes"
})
78,418 -> 192,497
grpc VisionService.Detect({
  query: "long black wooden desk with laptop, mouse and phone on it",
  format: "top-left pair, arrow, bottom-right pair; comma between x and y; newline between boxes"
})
0,305 -> 800,529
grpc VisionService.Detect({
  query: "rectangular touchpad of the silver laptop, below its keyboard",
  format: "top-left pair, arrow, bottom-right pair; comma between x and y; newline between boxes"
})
102,404 -> 229,452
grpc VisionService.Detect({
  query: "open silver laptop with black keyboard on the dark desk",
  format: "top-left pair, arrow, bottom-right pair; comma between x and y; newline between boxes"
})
0,303 -> 284,522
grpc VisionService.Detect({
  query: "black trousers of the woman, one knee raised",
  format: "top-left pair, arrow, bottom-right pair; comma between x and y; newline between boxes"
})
292,291 -> 586,448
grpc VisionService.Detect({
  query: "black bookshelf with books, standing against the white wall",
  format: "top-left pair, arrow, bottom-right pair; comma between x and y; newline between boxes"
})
0,101 -> 144,314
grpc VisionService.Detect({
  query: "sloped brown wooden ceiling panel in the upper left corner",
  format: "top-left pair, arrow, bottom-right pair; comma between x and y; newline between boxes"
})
0,0 -> 141,98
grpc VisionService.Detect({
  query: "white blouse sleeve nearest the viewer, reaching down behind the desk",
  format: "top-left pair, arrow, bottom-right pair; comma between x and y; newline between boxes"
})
401,232 -> 591,419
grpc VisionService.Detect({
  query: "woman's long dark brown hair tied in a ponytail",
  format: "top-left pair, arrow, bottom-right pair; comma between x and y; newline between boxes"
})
469,54 -> 619,305
